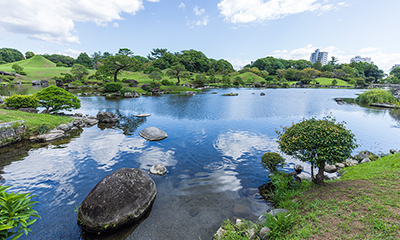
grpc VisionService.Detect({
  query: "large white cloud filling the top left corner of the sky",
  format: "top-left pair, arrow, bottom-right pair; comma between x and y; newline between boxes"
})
0,0 -> 143,44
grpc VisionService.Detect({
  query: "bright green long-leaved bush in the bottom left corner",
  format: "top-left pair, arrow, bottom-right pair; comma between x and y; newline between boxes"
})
0,186 -> 40,240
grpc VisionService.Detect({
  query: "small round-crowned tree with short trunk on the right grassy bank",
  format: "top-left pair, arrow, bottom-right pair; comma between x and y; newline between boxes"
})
277,117 -> 357,184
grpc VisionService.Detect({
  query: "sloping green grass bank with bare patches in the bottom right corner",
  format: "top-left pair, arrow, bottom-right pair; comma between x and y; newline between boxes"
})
217,153 -> 400,239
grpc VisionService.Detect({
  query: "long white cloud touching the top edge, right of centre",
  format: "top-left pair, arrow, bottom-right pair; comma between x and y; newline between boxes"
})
218,0 -> 347,23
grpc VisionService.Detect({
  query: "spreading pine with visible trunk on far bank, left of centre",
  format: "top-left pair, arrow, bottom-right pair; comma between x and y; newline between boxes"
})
97,48 -> 141,82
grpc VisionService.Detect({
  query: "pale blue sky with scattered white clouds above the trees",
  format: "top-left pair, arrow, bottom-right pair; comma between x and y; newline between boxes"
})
0,0 -> 400,72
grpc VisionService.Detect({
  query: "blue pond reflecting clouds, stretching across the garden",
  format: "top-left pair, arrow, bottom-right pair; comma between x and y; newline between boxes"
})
0,89 -> 400,239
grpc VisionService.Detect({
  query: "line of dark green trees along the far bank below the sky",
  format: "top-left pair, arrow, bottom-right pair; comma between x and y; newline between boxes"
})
0,48 -> 400,85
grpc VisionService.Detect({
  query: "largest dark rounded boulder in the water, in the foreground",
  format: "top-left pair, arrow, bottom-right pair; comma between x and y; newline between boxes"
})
78,168 -> 157,232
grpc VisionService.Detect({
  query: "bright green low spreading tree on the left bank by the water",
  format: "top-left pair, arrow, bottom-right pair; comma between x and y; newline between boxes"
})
36,86 -> 81,113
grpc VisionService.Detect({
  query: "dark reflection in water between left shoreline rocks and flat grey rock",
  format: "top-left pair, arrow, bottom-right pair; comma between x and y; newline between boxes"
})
98,109 -> 147,135
